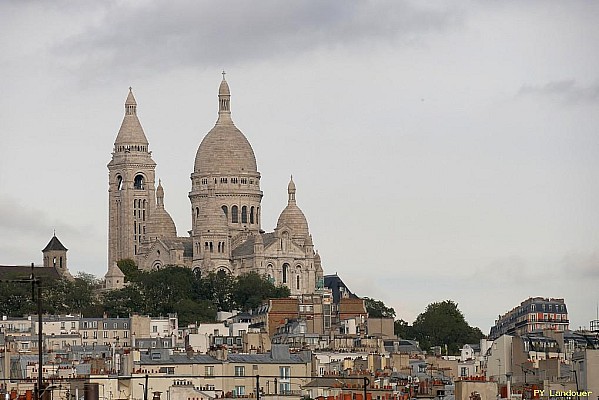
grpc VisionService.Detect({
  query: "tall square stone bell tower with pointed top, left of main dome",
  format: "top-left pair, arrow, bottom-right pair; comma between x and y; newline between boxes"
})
108,88 -> 156,266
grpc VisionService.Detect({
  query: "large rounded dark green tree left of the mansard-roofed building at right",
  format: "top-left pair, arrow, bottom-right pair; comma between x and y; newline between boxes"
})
412,300 -> 483,354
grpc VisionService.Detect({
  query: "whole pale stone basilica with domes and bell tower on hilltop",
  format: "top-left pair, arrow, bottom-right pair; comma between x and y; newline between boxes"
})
108,78 -> 323,295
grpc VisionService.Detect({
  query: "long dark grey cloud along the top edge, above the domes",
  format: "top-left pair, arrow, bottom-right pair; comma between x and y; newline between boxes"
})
55,0 -> 460,77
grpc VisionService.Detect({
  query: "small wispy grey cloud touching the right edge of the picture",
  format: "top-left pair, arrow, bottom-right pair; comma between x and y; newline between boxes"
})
518,79 -> 599,104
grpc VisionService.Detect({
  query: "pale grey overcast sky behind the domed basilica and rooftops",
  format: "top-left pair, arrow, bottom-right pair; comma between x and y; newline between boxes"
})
0,0 -> 599,333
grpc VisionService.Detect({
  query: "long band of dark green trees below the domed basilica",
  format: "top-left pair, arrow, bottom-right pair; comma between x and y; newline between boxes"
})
0,266 -> 290,326
